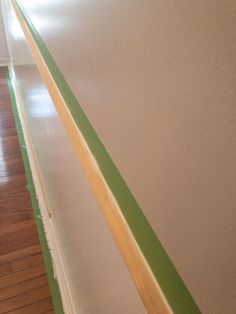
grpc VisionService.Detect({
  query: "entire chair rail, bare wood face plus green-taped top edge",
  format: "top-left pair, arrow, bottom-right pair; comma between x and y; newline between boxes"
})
12,0 -> 200,314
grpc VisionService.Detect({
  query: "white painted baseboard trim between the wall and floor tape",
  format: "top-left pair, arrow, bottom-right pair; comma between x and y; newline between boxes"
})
8,64 -> 78,314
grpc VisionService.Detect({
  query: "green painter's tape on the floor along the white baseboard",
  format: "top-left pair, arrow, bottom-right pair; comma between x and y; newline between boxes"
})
6,68 -> 64,314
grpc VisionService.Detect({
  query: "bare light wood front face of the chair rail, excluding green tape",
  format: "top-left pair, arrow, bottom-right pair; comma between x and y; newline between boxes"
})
12,1 -> 172,314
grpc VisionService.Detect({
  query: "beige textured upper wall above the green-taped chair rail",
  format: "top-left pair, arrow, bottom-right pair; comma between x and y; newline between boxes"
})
6,0 -> 236,314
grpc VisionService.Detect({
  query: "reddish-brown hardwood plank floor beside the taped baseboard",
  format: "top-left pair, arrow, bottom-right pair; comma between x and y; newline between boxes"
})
0,68 -> 54,314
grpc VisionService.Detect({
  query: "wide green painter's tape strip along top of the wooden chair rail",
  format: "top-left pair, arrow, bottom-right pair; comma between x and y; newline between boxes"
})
17,1 -> 200,314
